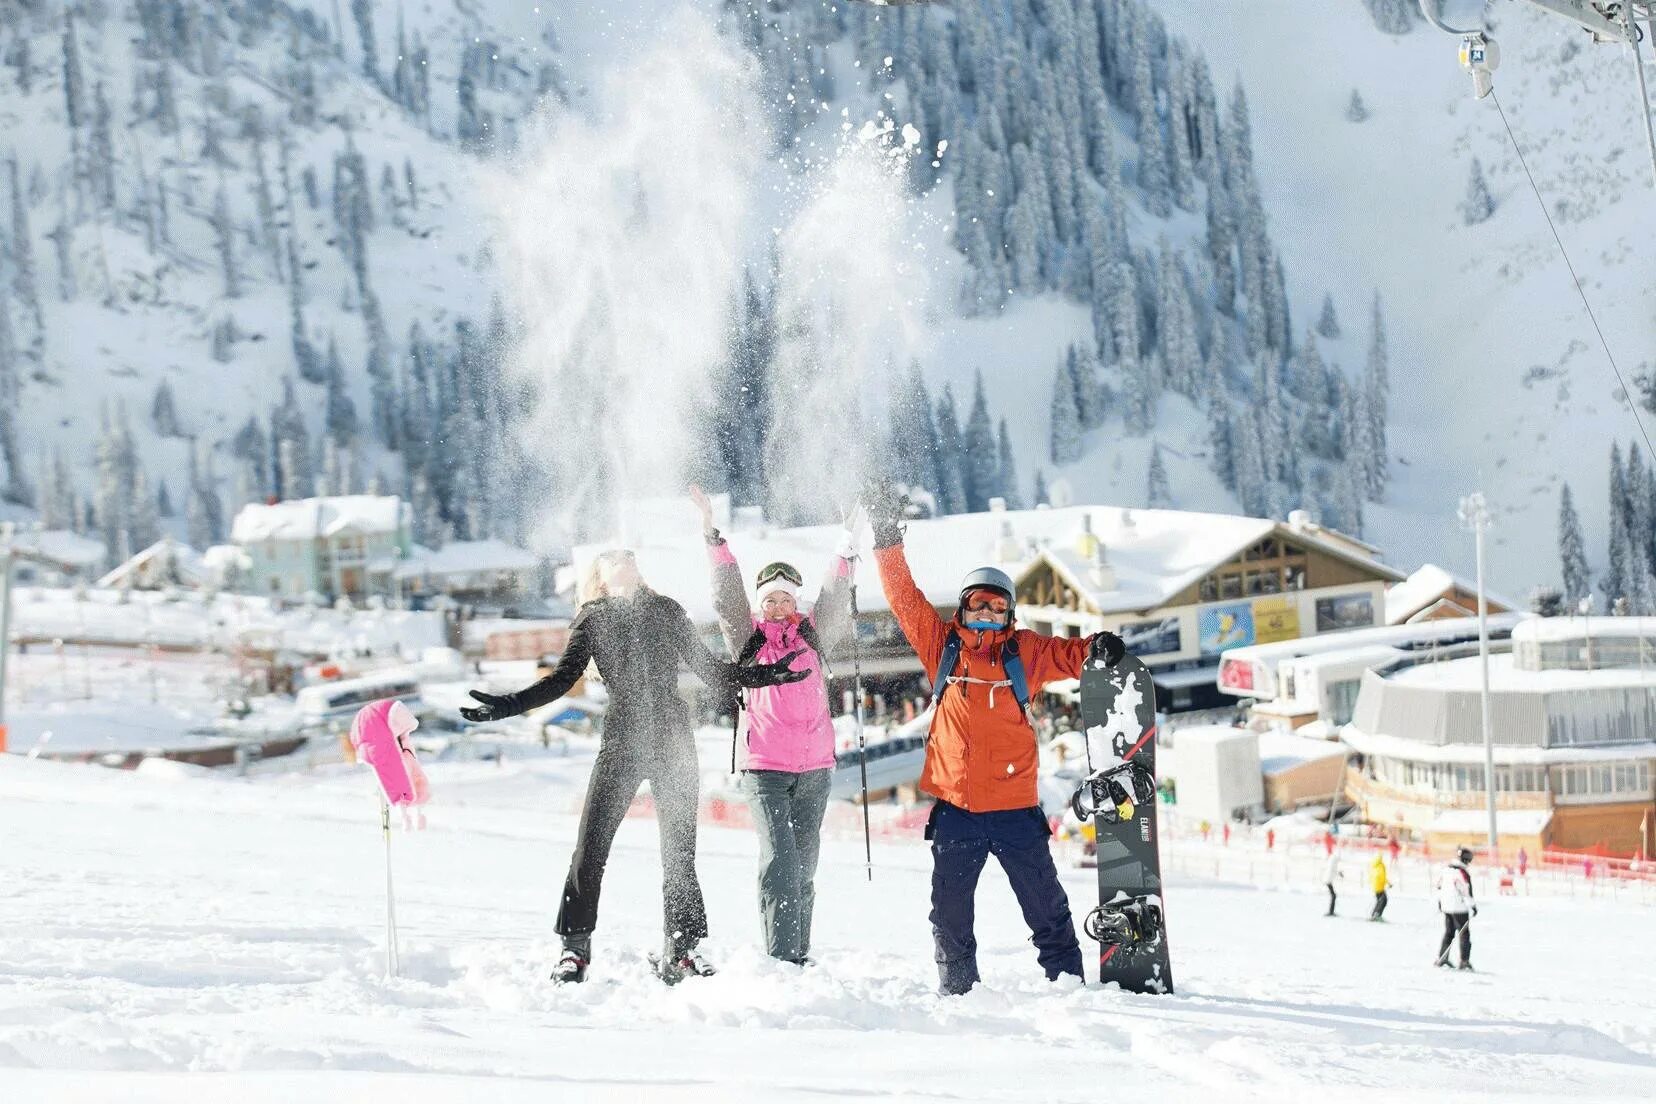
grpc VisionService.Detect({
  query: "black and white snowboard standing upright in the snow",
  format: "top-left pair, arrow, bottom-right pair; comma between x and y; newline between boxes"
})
1073,655 -> 1172,993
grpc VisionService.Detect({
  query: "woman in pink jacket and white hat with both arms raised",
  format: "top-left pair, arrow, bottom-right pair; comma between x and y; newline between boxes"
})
691,487 -> 853,965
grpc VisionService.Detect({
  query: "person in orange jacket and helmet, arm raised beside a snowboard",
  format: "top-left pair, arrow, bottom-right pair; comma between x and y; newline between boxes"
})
866,485 -> 1126,995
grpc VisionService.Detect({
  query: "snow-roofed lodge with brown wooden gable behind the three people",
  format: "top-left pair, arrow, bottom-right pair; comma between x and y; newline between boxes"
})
573,497 -> 1404,712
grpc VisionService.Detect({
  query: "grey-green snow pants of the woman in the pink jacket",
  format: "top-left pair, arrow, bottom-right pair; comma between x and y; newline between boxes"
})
742,766 -> 833,962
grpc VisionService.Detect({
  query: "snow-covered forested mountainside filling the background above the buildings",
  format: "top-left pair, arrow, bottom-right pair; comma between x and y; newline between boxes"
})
0,0 -> 1651,605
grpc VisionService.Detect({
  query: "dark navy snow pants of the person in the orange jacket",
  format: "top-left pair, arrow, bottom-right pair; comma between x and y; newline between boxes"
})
926,801 -> 1083,995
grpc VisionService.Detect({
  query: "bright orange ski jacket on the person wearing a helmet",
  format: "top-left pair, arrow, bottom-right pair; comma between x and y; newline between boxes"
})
874,545 -> 1090,813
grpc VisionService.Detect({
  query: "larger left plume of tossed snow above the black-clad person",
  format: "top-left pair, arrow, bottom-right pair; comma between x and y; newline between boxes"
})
492,10 -> 768,543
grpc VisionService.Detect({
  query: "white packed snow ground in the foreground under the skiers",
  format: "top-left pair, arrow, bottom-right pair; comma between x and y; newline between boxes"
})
0,753 -> 1656,1102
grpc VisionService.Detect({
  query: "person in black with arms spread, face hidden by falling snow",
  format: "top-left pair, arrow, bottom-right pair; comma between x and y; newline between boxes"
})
460,551 -> 810,982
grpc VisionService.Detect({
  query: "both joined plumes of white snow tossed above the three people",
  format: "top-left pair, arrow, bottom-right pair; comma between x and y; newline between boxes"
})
493,10 -> 939,543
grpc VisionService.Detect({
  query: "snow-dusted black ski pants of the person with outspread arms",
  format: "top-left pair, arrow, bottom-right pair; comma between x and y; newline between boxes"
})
556,732 -> 707,955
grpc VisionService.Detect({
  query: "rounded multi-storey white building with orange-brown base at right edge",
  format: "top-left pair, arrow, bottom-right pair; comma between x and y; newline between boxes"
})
1340,617 -> 1656,856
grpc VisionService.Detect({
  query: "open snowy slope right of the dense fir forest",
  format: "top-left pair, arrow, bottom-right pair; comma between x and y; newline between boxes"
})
1154,0 -> 1656,594
